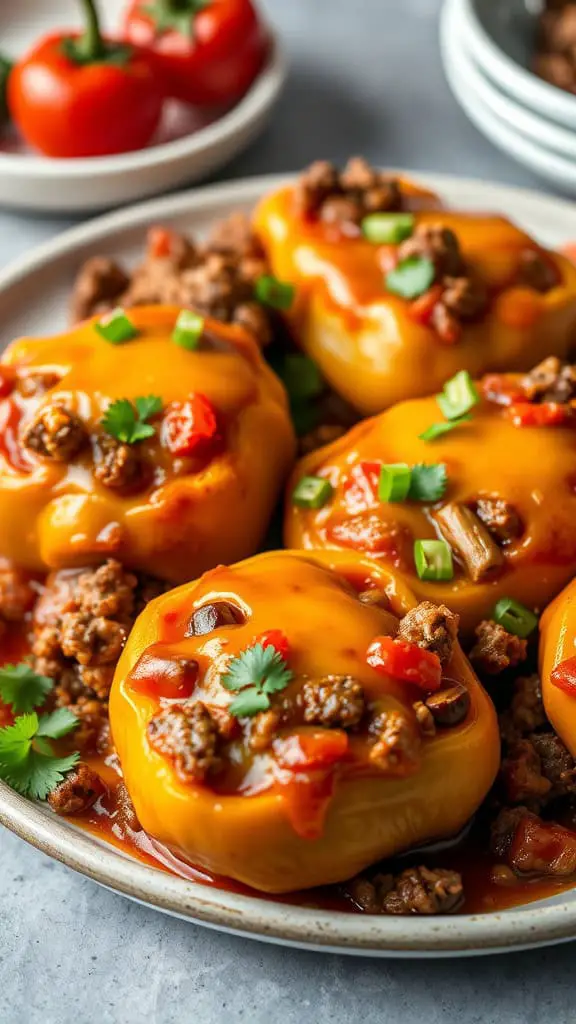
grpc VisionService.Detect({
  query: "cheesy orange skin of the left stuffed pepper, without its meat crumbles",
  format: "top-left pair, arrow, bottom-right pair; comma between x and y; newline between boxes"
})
0,306 -> 295,583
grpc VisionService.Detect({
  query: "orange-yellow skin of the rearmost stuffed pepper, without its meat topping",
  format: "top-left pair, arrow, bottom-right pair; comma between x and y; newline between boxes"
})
254,182 -> 576,416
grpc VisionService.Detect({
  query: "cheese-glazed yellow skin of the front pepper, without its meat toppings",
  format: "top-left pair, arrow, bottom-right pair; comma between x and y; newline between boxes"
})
110,552 -> 499,893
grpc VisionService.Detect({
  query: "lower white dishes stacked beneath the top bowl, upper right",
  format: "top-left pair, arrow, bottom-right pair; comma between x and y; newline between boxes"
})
440,0 -> 576,195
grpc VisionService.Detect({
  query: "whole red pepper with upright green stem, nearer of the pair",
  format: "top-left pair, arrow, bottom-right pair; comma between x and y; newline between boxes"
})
8,0 -> 165,158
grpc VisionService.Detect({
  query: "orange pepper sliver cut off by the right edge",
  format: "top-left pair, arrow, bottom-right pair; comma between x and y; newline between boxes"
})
539,581 -> 576,757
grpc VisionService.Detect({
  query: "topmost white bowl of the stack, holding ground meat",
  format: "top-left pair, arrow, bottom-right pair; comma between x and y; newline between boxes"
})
455,0 -> 576,128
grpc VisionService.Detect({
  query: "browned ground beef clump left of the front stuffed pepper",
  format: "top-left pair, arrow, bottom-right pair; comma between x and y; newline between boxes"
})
32,559 -> 143,729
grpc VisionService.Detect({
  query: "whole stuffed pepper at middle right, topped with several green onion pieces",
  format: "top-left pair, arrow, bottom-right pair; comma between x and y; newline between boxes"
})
285,357 -> 576,637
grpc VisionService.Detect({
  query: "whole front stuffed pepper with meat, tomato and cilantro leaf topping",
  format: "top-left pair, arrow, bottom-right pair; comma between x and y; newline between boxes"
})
110,552 -> 499,893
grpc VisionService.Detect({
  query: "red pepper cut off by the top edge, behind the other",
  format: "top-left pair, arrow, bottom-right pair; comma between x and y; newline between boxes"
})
124,0 -> 268,106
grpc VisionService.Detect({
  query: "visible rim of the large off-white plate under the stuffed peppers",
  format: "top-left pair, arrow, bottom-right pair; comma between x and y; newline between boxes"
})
0,172 -> 576,956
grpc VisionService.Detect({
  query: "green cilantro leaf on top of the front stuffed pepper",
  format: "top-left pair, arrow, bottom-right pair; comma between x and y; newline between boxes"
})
221,643 -> 293,718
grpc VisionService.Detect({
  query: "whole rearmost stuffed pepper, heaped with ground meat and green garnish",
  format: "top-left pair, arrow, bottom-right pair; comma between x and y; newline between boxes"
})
255,159 -> 576,415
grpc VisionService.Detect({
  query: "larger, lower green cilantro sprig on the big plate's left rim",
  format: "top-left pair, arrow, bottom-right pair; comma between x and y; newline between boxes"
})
0,709 -> 80,800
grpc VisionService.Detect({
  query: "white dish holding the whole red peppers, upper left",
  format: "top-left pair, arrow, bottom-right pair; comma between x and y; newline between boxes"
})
0,0 -> 287,212
